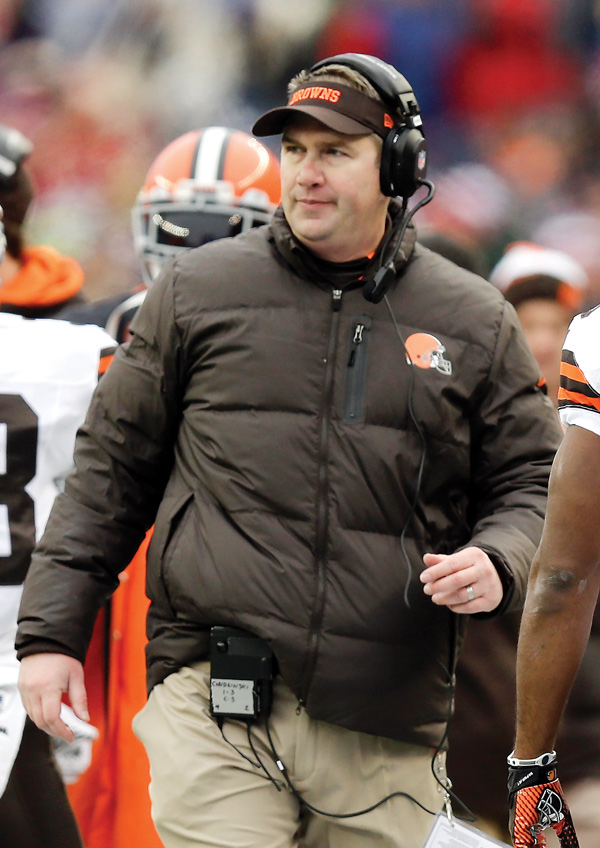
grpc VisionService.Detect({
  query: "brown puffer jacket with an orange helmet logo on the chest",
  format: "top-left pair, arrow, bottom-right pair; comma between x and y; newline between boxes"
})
18,202 -> 560,745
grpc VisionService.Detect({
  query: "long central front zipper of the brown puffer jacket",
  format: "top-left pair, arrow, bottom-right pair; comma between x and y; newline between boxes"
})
298,289 -> 343,708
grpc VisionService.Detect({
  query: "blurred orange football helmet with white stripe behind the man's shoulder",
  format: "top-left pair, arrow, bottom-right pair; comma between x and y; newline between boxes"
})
132,127 -> 281,285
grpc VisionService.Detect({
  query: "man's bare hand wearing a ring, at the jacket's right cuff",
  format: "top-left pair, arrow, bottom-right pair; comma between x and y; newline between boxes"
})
421,547 -> 504,615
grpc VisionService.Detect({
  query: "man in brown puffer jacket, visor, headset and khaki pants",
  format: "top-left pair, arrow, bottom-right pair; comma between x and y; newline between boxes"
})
17,54 -> 559,848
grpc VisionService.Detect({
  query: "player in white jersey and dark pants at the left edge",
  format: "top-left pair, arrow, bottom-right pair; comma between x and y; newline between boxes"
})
0,202 -> 114,848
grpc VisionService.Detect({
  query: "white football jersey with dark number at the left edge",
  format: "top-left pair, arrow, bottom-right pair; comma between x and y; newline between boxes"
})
0,313 -> 115,663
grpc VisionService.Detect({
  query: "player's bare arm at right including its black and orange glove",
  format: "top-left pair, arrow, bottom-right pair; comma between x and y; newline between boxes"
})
508,426 -> 600,848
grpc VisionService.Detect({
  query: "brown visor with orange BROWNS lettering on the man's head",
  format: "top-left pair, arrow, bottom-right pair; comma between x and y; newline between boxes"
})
252,79 -> 397,138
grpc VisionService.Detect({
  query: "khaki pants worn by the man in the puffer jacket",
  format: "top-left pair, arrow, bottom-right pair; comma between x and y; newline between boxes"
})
133,662 -> 443,848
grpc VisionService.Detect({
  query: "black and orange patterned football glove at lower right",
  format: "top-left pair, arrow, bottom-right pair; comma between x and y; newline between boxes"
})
508,757 -> 579,848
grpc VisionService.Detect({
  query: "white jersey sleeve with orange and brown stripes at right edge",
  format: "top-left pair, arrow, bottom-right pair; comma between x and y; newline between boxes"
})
558,306 -> 600,436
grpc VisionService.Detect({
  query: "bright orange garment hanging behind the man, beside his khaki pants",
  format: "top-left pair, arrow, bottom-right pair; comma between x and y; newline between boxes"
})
67,533 -> 163,848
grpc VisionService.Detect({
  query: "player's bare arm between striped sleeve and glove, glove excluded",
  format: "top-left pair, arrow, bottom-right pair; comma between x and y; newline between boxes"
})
515,426 -> 600,759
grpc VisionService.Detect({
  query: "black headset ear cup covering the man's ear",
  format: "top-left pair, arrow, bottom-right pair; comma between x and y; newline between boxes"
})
379,128 -> 427,198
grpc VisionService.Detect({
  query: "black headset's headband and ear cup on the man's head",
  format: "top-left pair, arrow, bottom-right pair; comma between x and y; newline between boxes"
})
308,53 -> 427,200
